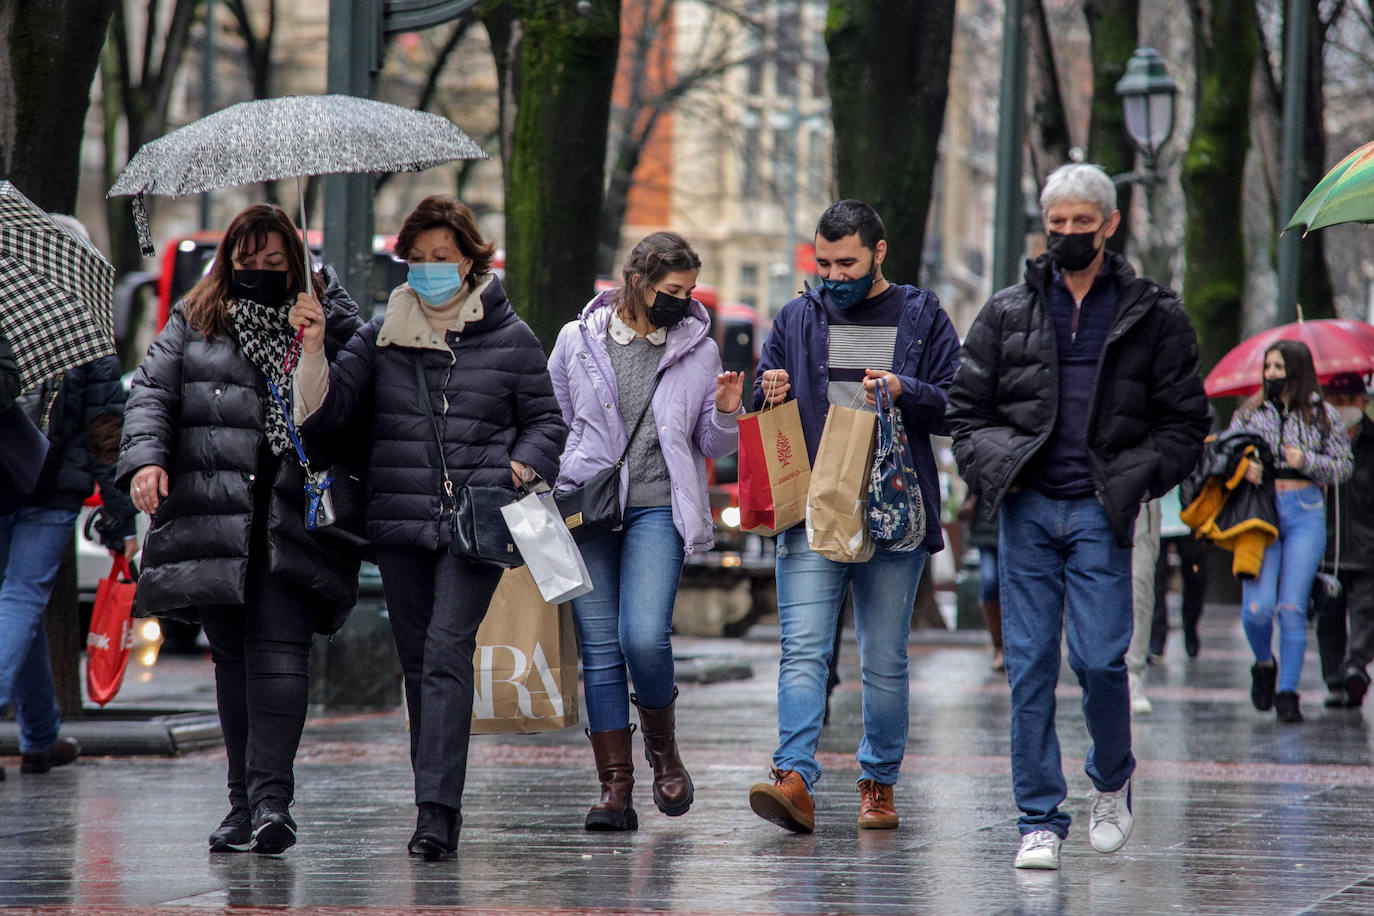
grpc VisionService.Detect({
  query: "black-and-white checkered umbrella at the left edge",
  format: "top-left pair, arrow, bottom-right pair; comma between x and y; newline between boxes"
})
0,181 -> 114,390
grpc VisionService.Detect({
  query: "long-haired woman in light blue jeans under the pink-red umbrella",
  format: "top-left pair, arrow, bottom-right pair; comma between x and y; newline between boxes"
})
1231,341 -> 1352,722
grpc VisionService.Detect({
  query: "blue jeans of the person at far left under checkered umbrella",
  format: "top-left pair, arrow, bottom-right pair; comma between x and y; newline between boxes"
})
0,508 -> 77,754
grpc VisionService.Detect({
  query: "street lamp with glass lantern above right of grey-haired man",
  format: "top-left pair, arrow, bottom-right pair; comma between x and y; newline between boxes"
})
1113,48 -> 1179,283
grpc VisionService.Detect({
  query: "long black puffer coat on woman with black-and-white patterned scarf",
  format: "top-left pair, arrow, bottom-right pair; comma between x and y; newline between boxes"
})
120,268 -> 360,633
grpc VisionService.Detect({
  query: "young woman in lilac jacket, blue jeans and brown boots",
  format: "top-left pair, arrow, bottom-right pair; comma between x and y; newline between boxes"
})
548,232 -> 743,831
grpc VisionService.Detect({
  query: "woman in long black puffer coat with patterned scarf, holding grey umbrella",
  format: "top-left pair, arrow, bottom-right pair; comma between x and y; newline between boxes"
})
118,205 -> 359,854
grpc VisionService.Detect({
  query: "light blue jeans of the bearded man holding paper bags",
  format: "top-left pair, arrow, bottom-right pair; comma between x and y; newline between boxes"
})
774,525 -> 929,790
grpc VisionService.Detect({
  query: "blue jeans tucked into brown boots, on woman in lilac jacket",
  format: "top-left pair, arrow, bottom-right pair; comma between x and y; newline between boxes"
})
573,505 -> 683,732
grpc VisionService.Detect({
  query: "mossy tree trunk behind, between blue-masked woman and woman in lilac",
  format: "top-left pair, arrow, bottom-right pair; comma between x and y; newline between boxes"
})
493,0 -> 620,349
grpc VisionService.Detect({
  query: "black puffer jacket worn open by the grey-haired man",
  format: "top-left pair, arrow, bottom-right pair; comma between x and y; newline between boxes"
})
948,251 -> 1208,547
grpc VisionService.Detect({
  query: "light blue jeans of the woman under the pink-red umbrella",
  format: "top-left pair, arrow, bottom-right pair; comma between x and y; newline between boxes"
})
1241,486 -> 1326,692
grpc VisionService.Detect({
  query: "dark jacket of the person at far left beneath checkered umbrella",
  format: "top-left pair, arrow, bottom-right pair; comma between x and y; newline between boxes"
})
29,356 -> 137,549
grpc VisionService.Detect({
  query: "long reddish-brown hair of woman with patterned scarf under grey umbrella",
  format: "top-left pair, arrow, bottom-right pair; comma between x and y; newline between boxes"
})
185,203 -> 324,338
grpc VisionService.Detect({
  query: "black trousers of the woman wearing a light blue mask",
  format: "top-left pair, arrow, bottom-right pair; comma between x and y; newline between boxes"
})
376,545 -> 502,810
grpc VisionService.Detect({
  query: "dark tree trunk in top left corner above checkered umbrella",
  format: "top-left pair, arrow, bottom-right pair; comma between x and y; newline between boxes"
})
0,0 -> 114,213
